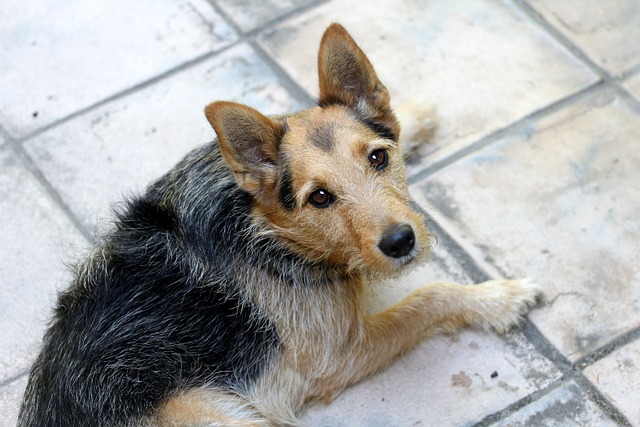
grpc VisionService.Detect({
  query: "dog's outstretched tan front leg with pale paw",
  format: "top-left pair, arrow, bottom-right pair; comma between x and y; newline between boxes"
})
319,279 -> 542,401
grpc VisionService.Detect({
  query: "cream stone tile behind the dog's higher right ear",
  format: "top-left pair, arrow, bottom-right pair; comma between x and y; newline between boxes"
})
259,0 -> 597,168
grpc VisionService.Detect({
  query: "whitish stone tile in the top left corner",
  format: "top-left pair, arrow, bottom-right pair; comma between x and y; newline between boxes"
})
0,0 -> 236,136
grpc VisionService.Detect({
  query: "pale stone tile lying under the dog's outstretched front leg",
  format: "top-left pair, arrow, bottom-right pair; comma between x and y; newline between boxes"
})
301,241 -> 560,426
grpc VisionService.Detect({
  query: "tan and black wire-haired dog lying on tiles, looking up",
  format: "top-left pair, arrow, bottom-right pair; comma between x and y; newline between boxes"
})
19,24 -> 541,426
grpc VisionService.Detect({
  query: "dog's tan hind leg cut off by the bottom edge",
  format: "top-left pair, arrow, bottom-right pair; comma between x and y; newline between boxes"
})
158,388 -> 273,427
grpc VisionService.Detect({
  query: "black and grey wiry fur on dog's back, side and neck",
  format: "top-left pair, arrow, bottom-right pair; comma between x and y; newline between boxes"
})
19,144 -> 342,426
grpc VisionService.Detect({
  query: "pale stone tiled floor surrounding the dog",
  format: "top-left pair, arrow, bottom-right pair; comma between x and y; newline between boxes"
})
0,0 -> 640,426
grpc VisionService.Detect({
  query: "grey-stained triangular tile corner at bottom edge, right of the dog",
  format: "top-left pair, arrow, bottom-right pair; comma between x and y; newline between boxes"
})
492,381 -> 618,427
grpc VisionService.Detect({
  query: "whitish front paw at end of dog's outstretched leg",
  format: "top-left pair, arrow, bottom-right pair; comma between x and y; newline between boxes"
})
475,278 -> 543,334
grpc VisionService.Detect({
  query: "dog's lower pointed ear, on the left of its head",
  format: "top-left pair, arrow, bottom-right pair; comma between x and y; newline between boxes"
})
205,101 -> 284,195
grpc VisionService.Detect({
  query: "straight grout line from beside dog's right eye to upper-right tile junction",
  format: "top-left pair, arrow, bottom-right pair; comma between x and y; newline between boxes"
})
408,80 -> 609,185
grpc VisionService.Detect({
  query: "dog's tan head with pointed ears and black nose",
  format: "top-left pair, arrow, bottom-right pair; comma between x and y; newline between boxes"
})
205,24 -> 429,274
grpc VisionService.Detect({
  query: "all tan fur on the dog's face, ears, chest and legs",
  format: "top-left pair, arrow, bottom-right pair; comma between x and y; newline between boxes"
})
158,24 -> 540,425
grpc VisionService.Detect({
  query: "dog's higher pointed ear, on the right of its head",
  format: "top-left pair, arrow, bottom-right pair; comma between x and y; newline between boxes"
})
318,23 -> 400,140
